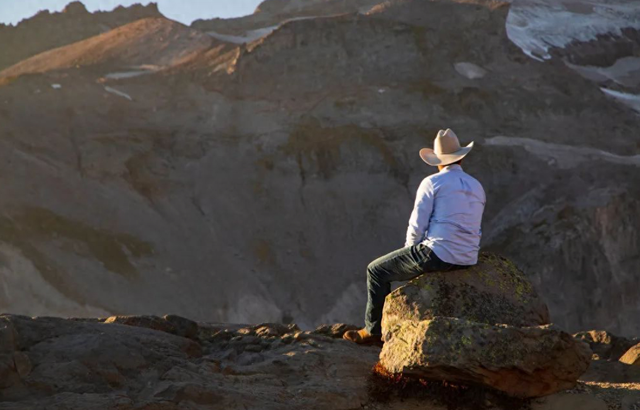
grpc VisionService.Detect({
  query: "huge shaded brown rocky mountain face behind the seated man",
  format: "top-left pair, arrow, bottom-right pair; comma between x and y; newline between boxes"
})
0,0 -> 640,335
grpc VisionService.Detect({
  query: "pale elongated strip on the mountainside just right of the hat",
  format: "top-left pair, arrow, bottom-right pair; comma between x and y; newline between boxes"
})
484,136 -> 640,169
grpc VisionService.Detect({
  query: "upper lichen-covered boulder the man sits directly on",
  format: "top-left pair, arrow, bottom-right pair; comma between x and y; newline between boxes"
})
382,253 -> 549,339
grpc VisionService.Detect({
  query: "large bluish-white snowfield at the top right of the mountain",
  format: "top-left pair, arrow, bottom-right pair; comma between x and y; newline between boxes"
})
506,0 -> 640,61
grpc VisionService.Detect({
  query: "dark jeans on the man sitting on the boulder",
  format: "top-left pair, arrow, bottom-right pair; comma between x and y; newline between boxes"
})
364,243 -> 462,335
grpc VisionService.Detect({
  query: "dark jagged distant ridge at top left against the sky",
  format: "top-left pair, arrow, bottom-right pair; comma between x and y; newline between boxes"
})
0,1 -> 161,70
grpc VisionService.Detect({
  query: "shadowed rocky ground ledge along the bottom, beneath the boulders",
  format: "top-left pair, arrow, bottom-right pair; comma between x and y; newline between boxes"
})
0,315 -> 640,410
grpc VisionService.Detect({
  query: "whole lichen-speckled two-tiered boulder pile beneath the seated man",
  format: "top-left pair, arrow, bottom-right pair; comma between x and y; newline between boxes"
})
380,253 -> 592,398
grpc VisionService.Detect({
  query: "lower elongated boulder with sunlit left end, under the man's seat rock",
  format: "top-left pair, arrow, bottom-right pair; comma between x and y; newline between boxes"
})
380,317 -> 591,397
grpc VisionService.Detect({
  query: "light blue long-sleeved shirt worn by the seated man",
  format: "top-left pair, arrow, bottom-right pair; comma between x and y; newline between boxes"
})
405,164 -> 486,265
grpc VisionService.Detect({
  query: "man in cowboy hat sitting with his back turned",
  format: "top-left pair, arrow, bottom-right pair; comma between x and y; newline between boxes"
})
344,129 -> 486,344
